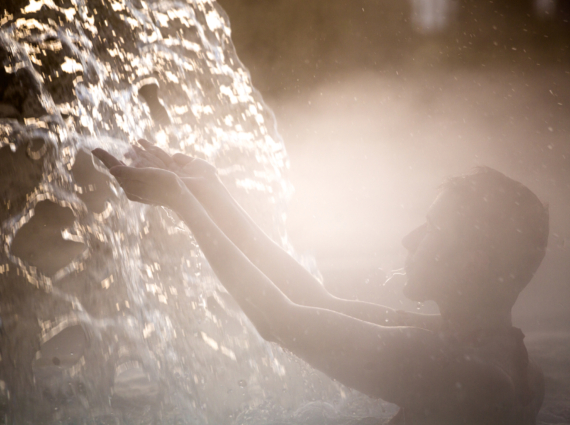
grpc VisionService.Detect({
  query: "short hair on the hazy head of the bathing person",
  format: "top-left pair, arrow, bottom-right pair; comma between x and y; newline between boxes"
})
442,167 -> 549,306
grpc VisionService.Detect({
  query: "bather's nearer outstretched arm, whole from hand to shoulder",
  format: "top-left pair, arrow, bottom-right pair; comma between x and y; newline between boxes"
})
96,166 -> 512,414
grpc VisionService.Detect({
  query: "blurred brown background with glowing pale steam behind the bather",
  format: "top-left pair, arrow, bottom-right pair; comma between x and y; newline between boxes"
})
214,0 -> 570,423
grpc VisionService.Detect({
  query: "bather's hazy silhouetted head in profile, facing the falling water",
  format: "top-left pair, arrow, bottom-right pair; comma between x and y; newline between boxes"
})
403,167 -> 549,311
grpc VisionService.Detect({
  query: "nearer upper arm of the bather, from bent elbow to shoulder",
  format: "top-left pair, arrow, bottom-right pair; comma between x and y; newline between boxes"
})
266,305 -> 512,410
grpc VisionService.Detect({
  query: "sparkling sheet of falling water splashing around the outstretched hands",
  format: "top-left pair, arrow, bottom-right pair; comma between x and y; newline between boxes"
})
0,0 -> 393,424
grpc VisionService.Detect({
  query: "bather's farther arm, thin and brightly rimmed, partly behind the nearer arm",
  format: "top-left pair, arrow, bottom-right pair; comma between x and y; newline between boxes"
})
94,144 -> 438,329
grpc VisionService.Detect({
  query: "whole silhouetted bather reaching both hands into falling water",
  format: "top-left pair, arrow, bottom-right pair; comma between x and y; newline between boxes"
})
93,140 -> 548,425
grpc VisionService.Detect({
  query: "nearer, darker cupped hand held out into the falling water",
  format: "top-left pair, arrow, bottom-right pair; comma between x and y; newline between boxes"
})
93,149 -> 186,208
